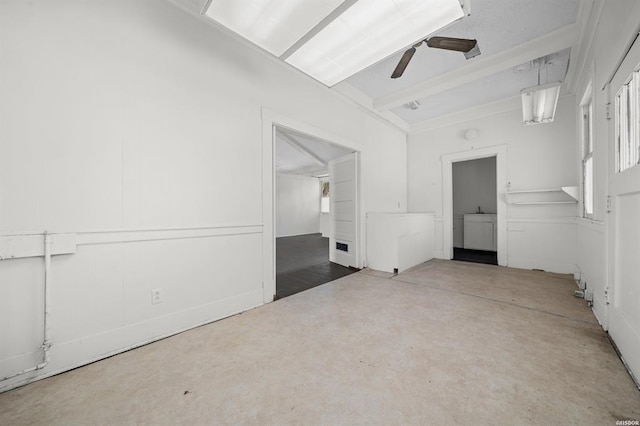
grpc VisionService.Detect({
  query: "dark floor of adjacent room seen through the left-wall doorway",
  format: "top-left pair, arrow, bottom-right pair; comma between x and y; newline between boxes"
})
276,233 -> 357,299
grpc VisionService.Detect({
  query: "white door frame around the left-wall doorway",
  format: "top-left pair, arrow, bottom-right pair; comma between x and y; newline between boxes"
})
262,107 -> 363,303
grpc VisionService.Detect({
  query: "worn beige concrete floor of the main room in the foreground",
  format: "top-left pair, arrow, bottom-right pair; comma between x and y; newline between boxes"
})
0,261 -> 640,425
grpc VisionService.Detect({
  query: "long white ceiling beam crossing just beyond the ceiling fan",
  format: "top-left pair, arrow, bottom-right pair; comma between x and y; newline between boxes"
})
373,24 -> 580,111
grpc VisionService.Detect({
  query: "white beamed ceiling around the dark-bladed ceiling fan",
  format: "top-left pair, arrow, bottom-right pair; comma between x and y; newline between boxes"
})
170,0 -> 595,130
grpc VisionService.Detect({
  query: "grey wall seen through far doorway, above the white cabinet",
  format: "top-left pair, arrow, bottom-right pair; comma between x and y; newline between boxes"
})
452,157 -> 497,247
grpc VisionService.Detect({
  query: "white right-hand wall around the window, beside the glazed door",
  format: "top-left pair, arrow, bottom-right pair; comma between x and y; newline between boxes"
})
574,0 -> 640,332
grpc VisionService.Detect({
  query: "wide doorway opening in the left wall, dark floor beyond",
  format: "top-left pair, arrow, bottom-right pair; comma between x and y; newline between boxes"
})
274,125 -> 357,299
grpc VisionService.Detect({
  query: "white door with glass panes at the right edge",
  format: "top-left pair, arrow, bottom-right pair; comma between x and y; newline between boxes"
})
607,38 -> 640,378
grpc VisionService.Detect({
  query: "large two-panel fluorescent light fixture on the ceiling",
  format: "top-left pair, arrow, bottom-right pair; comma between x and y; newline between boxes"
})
206,0 -> 465,86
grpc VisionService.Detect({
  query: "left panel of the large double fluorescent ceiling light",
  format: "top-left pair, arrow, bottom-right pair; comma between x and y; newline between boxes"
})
205,0 -> 344,56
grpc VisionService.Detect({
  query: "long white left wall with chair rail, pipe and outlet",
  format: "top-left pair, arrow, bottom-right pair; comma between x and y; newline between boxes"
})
0,0 -> 407,390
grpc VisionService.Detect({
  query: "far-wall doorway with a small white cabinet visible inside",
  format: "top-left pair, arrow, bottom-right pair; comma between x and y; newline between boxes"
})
452,156 -> 498,265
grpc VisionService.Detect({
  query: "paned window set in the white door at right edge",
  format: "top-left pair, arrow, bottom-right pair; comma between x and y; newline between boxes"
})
615,69 -> 640,173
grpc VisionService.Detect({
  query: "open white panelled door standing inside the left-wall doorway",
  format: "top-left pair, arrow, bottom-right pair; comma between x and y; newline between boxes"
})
329,152 -> 358,268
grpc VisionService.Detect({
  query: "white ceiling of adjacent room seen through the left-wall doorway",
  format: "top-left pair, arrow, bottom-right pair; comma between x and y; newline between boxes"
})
276,127 -> 353,176
